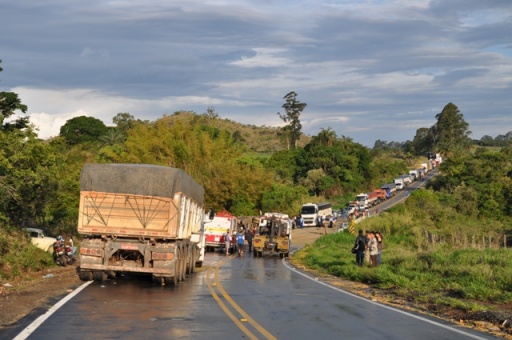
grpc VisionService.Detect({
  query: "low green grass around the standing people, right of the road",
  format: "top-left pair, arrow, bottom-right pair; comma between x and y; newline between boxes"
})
294,226 -> 512,311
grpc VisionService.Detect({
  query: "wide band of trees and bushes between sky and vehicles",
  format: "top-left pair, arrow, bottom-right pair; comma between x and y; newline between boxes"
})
0,65 -> 512,239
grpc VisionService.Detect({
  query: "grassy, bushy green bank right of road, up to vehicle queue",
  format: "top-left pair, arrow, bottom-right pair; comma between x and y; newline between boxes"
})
294,183 -> 512,312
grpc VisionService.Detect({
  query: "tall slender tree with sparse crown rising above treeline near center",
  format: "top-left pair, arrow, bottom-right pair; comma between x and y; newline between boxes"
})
277,91 -> 307,149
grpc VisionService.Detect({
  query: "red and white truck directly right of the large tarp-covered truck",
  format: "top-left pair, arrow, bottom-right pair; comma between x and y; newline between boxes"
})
204,210 -> 237,251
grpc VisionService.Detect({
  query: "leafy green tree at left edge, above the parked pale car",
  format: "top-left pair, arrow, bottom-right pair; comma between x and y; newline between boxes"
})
0,129 -> 65,230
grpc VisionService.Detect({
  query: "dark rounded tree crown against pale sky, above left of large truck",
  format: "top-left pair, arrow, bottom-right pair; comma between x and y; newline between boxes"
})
60,116 -> 108,145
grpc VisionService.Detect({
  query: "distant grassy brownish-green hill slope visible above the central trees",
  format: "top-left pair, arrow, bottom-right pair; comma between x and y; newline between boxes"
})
169,111 -> 311,153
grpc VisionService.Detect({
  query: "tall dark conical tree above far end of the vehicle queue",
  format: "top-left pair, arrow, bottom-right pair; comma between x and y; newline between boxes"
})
434,103 -> 471,157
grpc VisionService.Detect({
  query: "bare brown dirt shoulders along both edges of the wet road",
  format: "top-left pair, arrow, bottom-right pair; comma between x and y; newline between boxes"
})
0,228 -> 512,340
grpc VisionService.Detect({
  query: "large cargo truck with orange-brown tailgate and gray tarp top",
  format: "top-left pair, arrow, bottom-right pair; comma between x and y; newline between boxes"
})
78,164 -> 205,285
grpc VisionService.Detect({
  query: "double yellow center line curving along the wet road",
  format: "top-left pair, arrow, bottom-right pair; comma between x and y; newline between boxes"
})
206,258 -> 277,340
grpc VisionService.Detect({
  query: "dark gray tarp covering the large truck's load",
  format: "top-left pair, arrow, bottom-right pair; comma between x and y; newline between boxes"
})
80,164 -> 204,206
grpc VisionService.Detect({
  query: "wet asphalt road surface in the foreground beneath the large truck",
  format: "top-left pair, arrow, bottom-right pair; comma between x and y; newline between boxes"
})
10,247 -> 493,340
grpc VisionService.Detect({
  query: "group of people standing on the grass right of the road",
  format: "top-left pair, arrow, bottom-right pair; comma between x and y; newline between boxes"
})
352,230 -> 384,267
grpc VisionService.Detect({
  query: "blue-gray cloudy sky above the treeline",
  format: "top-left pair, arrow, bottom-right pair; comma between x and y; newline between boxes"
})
0,0 -> 512,147
